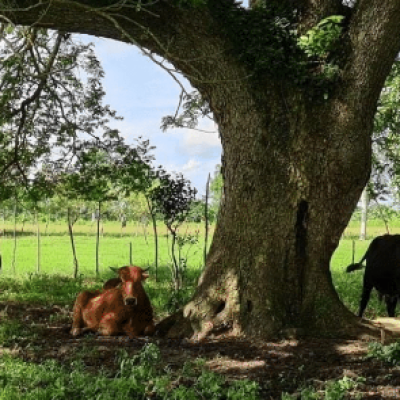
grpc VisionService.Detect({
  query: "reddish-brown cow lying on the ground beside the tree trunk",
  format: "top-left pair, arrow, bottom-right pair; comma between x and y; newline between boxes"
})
71,265 -> 155,338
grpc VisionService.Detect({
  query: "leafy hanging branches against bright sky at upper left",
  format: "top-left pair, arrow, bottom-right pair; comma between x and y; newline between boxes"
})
0,24 -> 121,194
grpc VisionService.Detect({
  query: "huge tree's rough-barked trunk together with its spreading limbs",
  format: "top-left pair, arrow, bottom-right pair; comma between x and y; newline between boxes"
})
3,0 -> 400,338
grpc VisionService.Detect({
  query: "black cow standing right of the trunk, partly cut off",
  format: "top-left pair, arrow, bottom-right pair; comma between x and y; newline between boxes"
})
346,235 -> 400,317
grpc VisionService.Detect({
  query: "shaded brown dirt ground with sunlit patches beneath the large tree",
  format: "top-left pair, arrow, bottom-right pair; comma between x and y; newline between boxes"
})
0,303 -> 400,400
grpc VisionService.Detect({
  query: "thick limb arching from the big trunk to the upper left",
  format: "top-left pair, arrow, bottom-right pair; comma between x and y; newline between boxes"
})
0,0 -> 250,84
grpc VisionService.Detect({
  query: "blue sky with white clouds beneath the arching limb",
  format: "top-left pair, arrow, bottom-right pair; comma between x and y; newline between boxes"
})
81,36 -> 221,198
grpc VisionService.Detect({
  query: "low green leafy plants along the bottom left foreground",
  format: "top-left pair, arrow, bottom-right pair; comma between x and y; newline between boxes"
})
0,344 -> 258,400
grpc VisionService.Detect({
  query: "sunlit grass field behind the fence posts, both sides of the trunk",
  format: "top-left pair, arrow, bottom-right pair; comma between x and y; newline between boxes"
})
0,221 -> 394,318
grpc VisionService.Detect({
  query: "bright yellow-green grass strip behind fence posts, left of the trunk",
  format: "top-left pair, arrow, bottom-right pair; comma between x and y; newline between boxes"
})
0,223 -> 204,276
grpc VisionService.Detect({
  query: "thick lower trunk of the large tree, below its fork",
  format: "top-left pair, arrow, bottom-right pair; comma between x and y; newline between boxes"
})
175,86 -> 372,337
